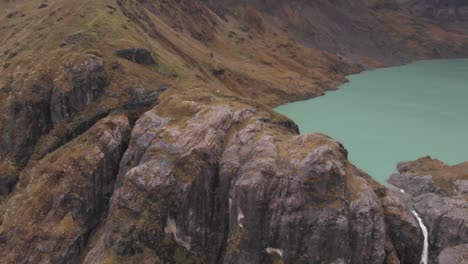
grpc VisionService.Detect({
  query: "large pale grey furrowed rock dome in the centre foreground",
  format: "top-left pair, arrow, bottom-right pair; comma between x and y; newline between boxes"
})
81,98 -> 422,263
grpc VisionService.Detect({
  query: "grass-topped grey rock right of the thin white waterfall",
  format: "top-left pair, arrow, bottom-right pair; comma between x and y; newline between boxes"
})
389,157 -> 468,264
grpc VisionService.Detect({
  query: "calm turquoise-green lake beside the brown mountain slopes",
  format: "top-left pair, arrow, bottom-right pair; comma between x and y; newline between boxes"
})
275,59 -> 468,182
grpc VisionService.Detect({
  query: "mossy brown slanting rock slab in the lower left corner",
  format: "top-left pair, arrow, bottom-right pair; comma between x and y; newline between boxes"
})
0,116 -> 130,263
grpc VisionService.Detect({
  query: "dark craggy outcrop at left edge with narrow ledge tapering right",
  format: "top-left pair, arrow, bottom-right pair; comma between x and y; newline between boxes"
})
0,51 -> 168,196
